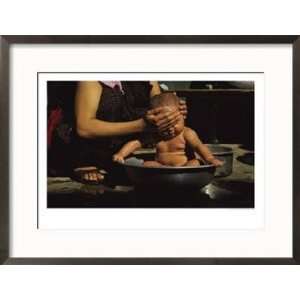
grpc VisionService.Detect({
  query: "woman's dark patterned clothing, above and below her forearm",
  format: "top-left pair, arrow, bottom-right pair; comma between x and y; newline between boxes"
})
73,81 -> 152,168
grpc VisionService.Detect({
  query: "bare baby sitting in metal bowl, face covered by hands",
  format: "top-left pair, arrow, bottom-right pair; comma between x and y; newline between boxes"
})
113,92 -> 223,167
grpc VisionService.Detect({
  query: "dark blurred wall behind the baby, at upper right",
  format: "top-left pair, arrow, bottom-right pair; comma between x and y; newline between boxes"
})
162,81 -> 254,149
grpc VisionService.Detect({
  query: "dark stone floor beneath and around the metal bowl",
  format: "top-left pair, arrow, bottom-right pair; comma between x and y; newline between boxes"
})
48,145 -> 254,208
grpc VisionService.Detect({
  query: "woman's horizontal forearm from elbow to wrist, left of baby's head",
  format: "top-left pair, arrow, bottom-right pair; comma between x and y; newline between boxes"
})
77,119 -> 146,138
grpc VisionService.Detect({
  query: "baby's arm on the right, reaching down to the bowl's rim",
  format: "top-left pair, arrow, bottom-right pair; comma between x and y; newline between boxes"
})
184,127 -> 223,167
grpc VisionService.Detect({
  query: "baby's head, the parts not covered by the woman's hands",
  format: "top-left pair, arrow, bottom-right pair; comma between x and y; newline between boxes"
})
150,92 -> 184,135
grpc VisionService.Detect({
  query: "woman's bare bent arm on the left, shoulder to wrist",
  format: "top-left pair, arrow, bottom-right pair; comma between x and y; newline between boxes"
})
75,81 -> 146,138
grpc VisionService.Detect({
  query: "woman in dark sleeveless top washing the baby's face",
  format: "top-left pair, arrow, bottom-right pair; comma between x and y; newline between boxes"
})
74,81 -> 186,184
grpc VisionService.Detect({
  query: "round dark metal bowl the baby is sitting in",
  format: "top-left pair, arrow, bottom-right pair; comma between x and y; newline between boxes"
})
123,158 -> 215,189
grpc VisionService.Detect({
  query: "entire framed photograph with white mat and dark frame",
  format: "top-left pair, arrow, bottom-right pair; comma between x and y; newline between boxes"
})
0,36 -> 300,264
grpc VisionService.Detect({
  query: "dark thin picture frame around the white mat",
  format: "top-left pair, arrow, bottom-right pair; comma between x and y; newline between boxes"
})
0,35 -> 300,265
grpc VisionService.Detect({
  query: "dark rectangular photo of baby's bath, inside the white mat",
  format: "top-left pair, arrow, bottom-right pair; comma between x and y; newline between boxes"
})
46,78 -> 255,209
